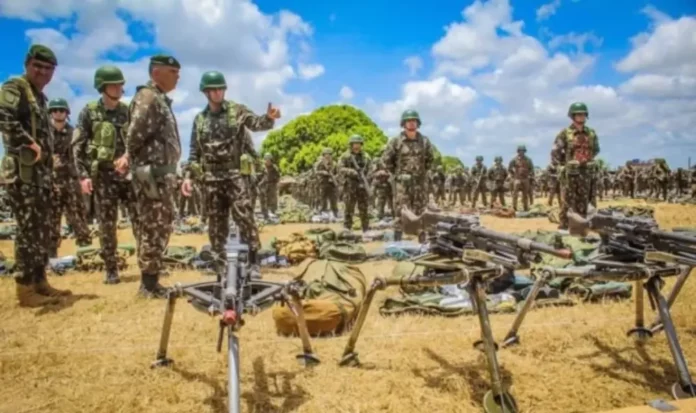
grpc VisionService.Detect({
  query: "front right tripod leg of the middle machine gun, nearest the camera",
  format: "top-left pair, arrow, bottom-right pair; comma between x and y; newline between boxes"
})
469,277 -> 518,413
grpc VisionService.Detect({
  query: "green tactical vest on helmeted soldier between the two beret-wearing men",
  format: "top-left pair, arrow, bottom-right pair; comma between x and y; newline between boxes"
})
87,101 -> 128,176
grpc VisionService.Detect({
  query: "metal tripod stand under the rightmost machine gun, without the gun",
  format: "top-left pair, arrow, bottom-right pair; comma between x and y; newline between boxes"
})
503,253 -> 696,400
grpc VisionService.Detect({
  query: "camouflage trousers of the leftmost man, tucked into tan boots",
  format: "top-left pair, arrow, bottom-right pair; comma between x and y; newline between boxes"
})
6,182 -> 53,285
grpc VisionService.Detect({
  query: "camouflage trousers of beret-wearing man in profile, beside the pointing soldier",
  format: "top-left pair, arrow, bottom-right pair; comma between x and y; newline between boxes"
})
133,175 -> 179,276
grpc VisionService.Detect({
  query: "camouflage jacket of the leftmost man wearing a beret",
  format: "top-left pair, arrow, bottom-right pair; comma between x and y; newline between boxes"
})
0,76 -> 53,188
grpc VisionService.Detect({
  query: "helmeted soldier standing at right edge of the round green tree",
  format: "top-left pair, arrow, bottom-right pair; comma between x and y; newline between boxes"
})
382,110 -> 434,241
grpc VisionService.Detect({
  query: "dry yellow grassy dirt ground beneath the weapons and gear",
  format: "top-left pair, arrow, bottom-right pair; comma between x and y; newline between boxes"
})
0,197 -> 696,413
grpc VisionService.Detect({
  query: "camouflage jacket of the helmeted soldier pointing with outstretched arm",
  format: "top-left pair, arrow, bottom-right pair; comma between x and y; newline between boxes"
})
189,100 -> 275,181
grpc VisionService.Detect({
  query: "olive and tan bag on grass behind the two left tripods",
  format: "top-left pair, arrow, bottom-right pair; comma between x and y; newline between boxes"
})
273,258 -> 367,337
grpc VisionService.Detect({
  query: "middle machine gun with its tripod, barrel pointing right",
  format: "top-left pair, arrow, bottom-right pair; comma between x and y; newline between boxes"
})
340,208 -> 570,413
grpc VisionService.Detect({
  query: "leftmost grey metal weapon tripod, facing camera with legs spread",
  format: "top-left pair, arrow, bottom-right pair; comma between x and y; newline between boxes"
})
152,229 -> 319,413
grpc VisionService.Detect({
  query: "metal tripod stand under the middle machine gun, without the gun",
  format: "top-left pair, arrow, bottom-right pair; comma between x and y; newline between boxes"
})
339,261 -> 518,413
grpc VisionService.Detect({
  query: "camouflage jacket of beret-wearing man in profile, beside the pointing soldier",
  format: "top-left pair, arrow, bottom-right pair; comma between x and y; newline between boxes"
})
126,81 -> 181,167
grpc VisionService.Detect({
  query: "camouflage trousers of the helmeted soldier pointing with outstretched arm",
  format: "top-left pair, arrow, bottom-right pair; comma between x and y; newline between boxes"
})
205,176 -> 261,255
